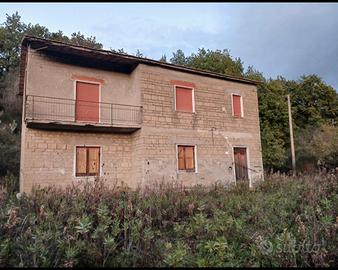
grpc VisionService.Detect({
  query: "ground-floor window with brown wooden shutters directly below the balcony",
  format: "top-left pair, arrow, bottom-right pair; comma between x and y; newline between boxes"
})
75,146 -> 100,176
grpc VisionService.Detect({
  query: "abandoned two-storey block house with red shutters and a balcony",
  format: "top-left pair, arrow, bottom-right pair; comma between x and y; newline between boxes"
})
20,36 -> 263,192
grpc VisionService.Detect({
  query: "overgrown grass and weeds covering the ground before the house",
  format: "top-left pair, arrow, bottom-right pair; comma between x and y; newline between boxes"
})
0,174 -> 338,267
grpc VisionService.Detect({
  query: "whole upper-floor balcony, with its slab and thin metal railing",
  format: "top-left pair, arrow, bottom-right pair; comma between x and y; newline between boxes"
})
25,95 -> 142,133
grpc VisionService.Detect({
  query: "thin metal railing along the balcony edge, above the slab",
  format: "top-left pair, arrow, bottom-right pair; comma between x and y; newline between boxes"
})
25,95 -> 142,126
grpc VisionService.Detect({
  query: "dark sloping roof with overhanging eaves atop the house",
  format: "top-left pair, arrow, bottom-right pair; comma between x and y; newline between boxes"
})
20,35 -> 261,93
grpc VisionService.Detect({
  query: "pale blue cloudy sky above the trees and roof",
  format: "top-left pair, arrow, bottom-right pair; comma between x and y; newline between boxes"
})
0,3 -> 338,90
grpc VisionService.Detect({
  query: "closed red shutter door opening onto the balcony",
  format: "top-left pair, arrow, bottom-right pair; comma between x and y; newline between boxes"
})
75,82 -> 100,122
